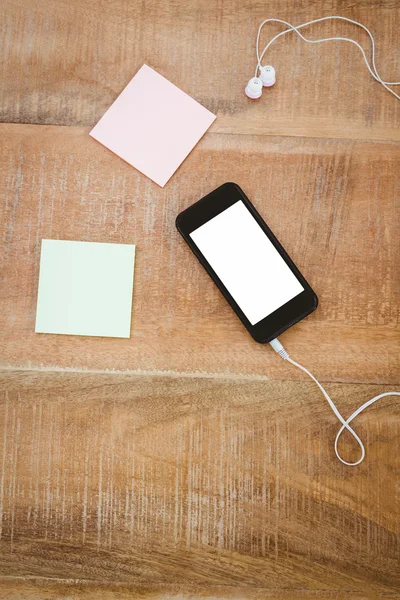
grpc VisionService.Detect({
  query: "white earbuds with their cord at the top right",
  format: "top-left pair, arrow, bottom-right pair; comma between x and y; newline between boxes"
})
245,15 -> 400,100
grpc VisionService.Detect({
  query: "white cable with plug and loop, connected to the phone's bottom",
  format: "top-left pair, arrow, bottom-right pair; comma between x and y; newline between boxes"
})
270,338 -> 400,467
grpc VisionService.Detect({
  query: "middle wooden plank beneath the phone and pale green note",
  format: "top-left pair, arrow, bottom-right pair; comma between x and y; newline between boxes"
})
0,125 -> 400,383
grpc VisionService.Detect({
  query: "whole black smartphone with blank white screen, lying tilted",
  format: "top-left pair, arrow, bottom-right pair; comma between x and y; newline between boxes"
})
176,183 -> 318,344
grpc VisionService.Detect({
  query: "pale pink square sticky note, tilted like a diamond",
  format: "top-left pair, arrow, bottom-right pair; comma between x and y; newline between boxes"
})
90,65 -> 216,187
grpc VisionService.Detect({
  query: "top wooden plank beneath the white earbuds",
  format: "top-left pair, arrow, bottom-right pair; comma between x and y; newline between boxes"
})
0,0 -> 400,141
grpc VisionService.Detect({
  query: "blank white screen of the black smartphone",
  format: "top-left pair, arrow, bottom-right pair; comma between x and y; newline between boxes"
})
190,200 -> 304,325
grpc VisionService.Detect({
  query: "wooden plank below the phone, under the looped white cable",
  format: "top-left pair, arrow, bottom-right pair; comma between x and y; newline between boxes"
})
0,372 -> 400,598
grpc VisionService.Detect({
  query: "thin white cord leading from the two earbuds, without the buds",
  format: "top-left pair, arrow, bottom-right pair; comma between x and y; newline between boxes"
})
255,15 -> 400,100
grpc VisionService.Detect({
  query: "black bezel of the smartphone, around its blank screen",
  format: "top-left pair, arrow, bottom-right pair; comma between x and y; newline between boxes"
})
176,182 -> 318,344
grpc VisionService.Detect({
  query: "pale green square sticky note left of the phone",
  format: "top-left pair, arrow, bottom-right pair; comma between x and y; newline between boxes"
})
35,240 -> 135,338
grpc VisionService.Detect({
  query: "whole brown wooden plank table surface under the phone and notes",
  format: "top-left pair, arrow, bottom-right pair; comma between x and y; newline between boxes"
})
0,0 -> 400,600
